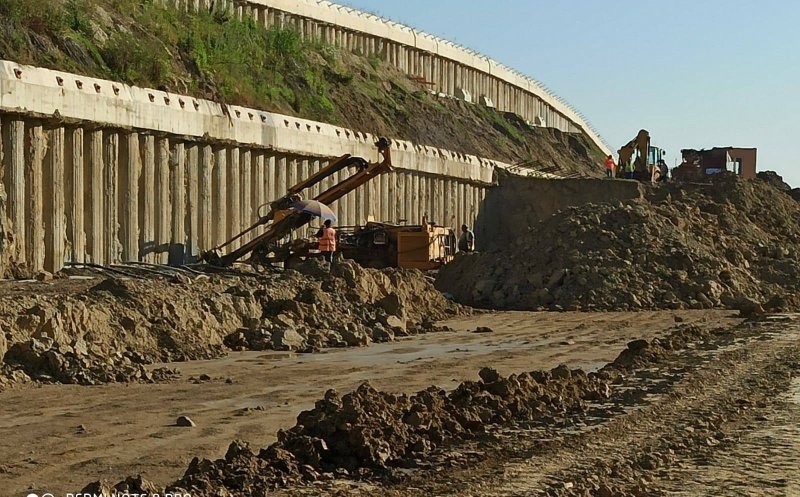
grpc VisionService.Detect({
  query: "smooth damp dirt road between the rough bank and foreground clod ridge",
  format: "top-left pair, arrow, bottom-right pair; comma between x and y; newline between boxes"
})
0,311 -> 739,496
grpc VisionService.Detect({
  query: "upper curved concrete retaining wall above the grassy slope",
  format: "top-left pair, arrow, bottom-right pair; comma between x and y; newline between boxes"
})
153,0 -> 611,154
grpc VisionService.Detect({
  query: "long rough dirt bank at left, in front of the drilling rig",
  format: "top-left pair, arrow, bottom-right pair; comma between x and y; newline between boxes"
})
0,261 -> 467,384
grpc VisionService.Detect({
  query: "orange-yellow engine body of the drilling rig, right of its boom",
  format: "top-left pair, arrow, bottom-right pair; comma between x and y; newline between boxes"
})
338,218 -> 457,271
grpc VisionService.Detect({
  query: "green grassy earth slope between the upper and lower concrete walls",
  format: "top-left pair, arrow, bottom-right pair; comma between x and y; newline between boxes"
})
0,0 -> 601,174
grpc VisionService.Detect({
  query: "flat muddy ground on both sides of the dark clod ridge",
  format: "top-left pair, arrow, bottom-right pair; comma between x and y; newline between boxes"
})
0,311 -> 800,495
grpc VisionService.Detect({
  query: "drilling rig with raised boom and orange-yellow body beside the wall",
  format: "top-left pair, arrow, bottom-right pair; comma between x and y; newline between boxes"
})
201,138 -> 456,270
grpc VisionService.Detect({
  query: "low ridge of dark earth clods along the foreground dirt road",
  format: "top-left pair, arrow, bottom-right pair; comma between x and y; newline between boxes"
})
145,366 -> 611,497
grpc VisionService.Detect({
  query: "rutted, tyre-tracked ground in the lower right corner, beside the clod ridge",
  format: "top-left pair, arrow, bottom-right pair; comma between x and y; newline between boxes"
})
278,321 -> 800,497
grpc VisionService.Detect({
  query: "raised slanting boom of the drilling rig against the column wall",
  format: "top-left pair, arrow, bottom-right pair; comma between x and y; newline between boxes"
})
201,138 -> 392,267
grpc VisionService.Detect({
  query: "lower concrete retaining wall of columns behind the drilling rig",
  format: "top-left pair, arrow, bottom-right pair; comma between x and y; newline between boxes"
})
0,61 -> 508,271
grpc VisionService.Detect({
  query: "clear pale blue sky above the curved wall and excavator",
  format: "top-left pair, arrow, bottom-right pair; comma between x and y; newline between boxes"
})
340,0 -> 800,187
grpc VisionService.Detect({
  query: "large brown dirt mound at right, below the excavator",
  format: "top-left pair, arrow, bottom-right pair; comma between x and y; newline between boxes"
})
436,175 -> 800,310
